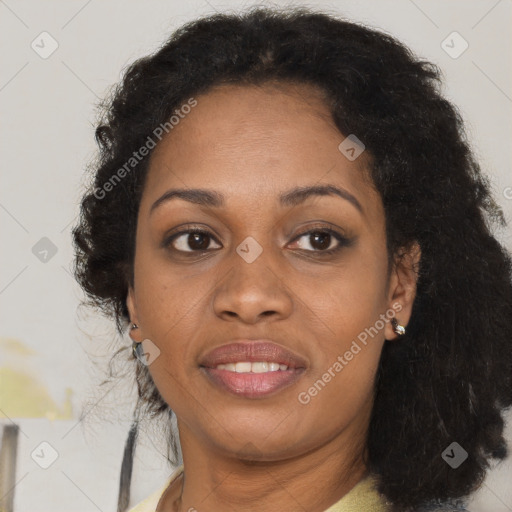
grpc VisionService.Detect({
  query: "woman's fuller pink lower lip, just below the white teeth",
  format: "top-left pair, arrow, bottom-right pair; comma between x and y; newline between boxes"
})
201,367 -> 304,398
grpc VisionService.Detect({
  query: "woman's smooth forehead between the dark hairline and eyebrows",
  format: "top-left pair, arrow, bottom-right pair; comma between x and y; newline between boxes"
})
141,84 -> 378,220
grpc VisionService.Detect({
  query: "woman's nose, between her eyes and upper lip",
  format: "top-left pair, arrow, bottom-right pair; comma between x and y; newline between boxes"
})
213,247 -> 293,324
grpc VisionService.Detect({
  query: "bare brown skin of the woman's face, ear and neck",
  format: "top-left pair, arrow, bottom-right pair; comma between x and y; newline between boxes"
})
127,84 -> 420,512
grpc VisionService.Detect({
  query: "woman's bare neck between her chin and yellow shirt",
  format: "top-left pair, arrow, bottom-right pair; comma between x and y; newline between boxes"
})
157,418 -> 368,512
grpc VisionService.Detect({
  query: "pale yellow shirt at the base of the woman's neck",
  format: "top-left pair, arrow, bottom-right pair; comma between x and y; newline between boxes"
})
129,464 -> 390,512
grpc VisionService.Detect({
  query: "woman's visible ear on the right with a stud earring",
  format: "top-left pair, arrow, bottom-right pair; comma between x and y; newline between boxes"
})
385,241 -> 421,340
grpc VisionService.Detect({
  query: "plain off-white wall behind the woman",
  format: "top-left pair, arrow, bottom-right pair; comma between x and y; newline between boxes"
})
0,0 -> 512,512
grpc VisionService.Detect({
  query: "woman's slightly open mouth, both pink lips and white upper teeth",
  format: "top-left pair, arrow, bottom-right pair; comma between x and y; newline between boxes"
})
199,340 -> 308,399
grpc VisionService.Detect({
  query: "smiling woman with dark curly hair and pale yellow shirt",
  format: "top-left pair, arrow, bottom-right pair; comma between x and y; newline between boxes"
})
74,5 -> 512,512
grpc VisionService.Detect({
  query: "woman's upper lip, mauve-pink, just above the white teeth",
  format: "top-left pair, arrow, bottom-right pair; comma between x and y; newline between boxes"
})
199,339 -> 307,368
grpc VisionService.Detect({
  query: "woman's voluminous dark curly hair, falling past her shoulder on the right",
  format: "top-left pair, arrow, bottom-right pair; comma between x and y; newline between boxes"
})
73,7 -> 512,511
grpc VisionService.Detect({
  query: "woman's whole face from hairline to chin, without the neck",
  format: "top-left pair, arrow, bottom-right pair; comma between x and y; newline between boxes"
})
128,85 -> 420,460
